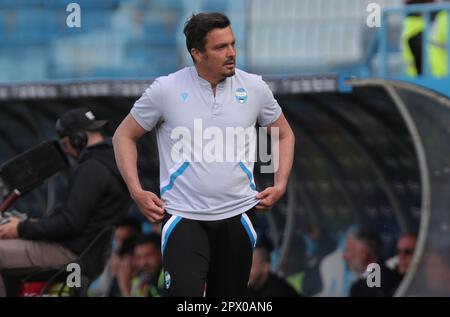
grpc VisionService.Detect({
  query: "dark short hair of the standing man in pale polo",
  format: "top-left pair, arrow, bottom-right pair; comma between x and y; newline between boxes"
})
183,12 -> 230,62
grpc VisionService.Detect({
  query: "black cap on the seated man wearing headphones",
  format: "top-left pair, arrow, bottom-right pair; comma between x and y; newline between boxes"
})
56,108 -> 108,138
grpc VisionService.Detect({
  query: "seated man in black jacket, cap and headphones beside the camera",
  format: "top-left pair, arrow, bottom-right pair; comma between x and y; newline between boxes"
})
0,108 -> 130,296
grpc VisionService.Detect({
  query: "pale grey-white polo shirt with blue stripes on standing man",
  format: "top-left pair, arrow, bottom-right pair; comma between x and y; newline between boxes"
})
131,67 -> 281,221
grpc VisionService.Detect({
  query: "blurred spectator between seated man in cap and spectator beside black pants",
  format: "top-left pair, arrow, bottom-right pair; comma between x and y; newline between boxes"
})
89,217 -> 141,297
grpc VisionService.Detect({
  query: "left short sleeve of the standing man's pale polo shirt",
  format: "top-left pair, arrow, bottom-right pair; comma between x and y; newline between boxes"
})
130,79 -> 162,131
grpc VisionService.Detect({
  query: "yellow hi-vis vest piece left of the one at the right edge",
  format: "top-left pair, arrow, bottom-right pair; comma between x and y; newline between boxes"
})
402,16 -> 425,77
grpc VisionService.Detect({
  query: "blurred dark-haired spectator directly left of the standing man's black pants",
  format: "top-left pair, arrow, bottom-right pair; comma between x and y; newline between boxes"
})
117,233 -> 164,297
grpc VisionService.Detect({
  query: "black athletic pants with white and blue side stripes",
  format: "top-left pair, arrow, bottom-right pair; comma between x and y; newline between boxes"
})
161,209 -> 257,297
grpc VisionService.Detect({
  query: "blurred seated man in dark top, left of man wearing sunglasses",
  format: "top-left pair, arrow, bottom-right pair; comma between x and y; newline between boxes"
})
344,228 -> 398,297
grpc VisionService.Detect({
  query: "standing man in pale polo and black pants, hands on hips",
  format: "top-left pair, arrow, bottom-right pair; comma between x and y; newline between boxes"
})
113,13 -> 294,296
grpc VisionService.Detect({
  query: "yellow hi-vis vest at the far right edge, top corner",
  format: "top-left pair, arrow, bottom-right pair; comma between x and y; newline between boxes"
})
429,11 -> 448,77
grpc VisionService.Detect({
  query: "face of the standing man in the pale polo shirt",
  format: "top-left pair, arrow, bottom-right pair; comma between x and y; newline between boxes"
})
194,26 -> 236,78
